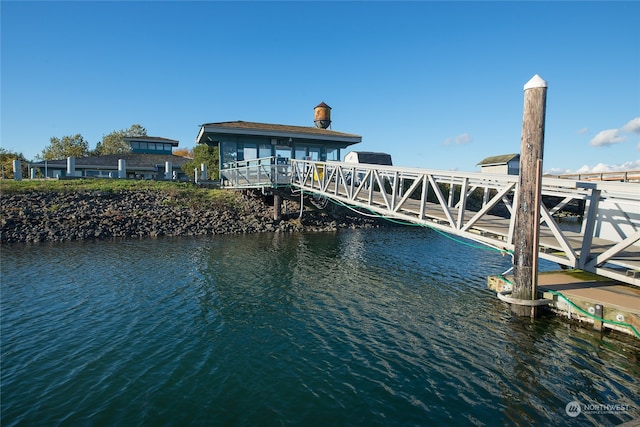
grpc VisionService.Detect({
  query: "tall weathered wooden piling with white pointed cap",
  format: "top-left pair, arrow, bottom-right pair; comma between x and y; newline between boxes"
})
511,74 -> 547,316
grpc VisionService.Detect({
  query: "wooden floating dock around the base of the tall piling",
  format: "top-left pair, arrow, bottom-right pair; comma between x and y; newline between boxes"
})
487,270 -> 640,339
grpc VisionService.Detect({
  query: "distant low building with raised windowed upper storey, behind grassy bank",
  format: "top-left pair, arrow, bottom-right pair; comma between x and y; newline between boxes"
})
29,136 -> 190,179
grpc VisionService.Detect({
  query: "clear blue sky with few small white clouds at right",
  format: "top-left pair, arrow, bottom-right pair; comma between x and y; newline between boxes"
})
0,1 -> 640,172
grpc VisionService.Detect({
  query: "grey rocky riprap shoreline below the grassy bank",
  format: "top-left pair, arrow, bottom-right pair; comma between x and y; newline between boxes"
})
0,191 -> 388,243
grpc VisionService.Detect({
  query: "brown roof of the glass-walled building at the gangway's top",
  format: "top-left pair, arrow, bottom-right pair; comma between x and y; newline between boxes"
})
196,120 -> 362,145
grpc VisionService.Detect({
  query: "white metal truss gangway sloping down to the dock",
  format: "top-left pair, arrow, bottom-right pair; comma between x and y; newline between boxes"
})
221,158 -> 640,286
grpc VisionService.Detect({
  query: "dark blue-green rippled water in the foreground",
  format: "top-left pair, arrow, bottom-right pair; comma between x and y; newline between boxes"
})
1,228 -> 640,426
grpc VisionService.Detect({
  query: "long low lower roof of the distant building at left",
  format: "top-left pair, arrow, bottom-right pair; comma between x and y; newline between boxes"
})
31,153 -> 191,170
